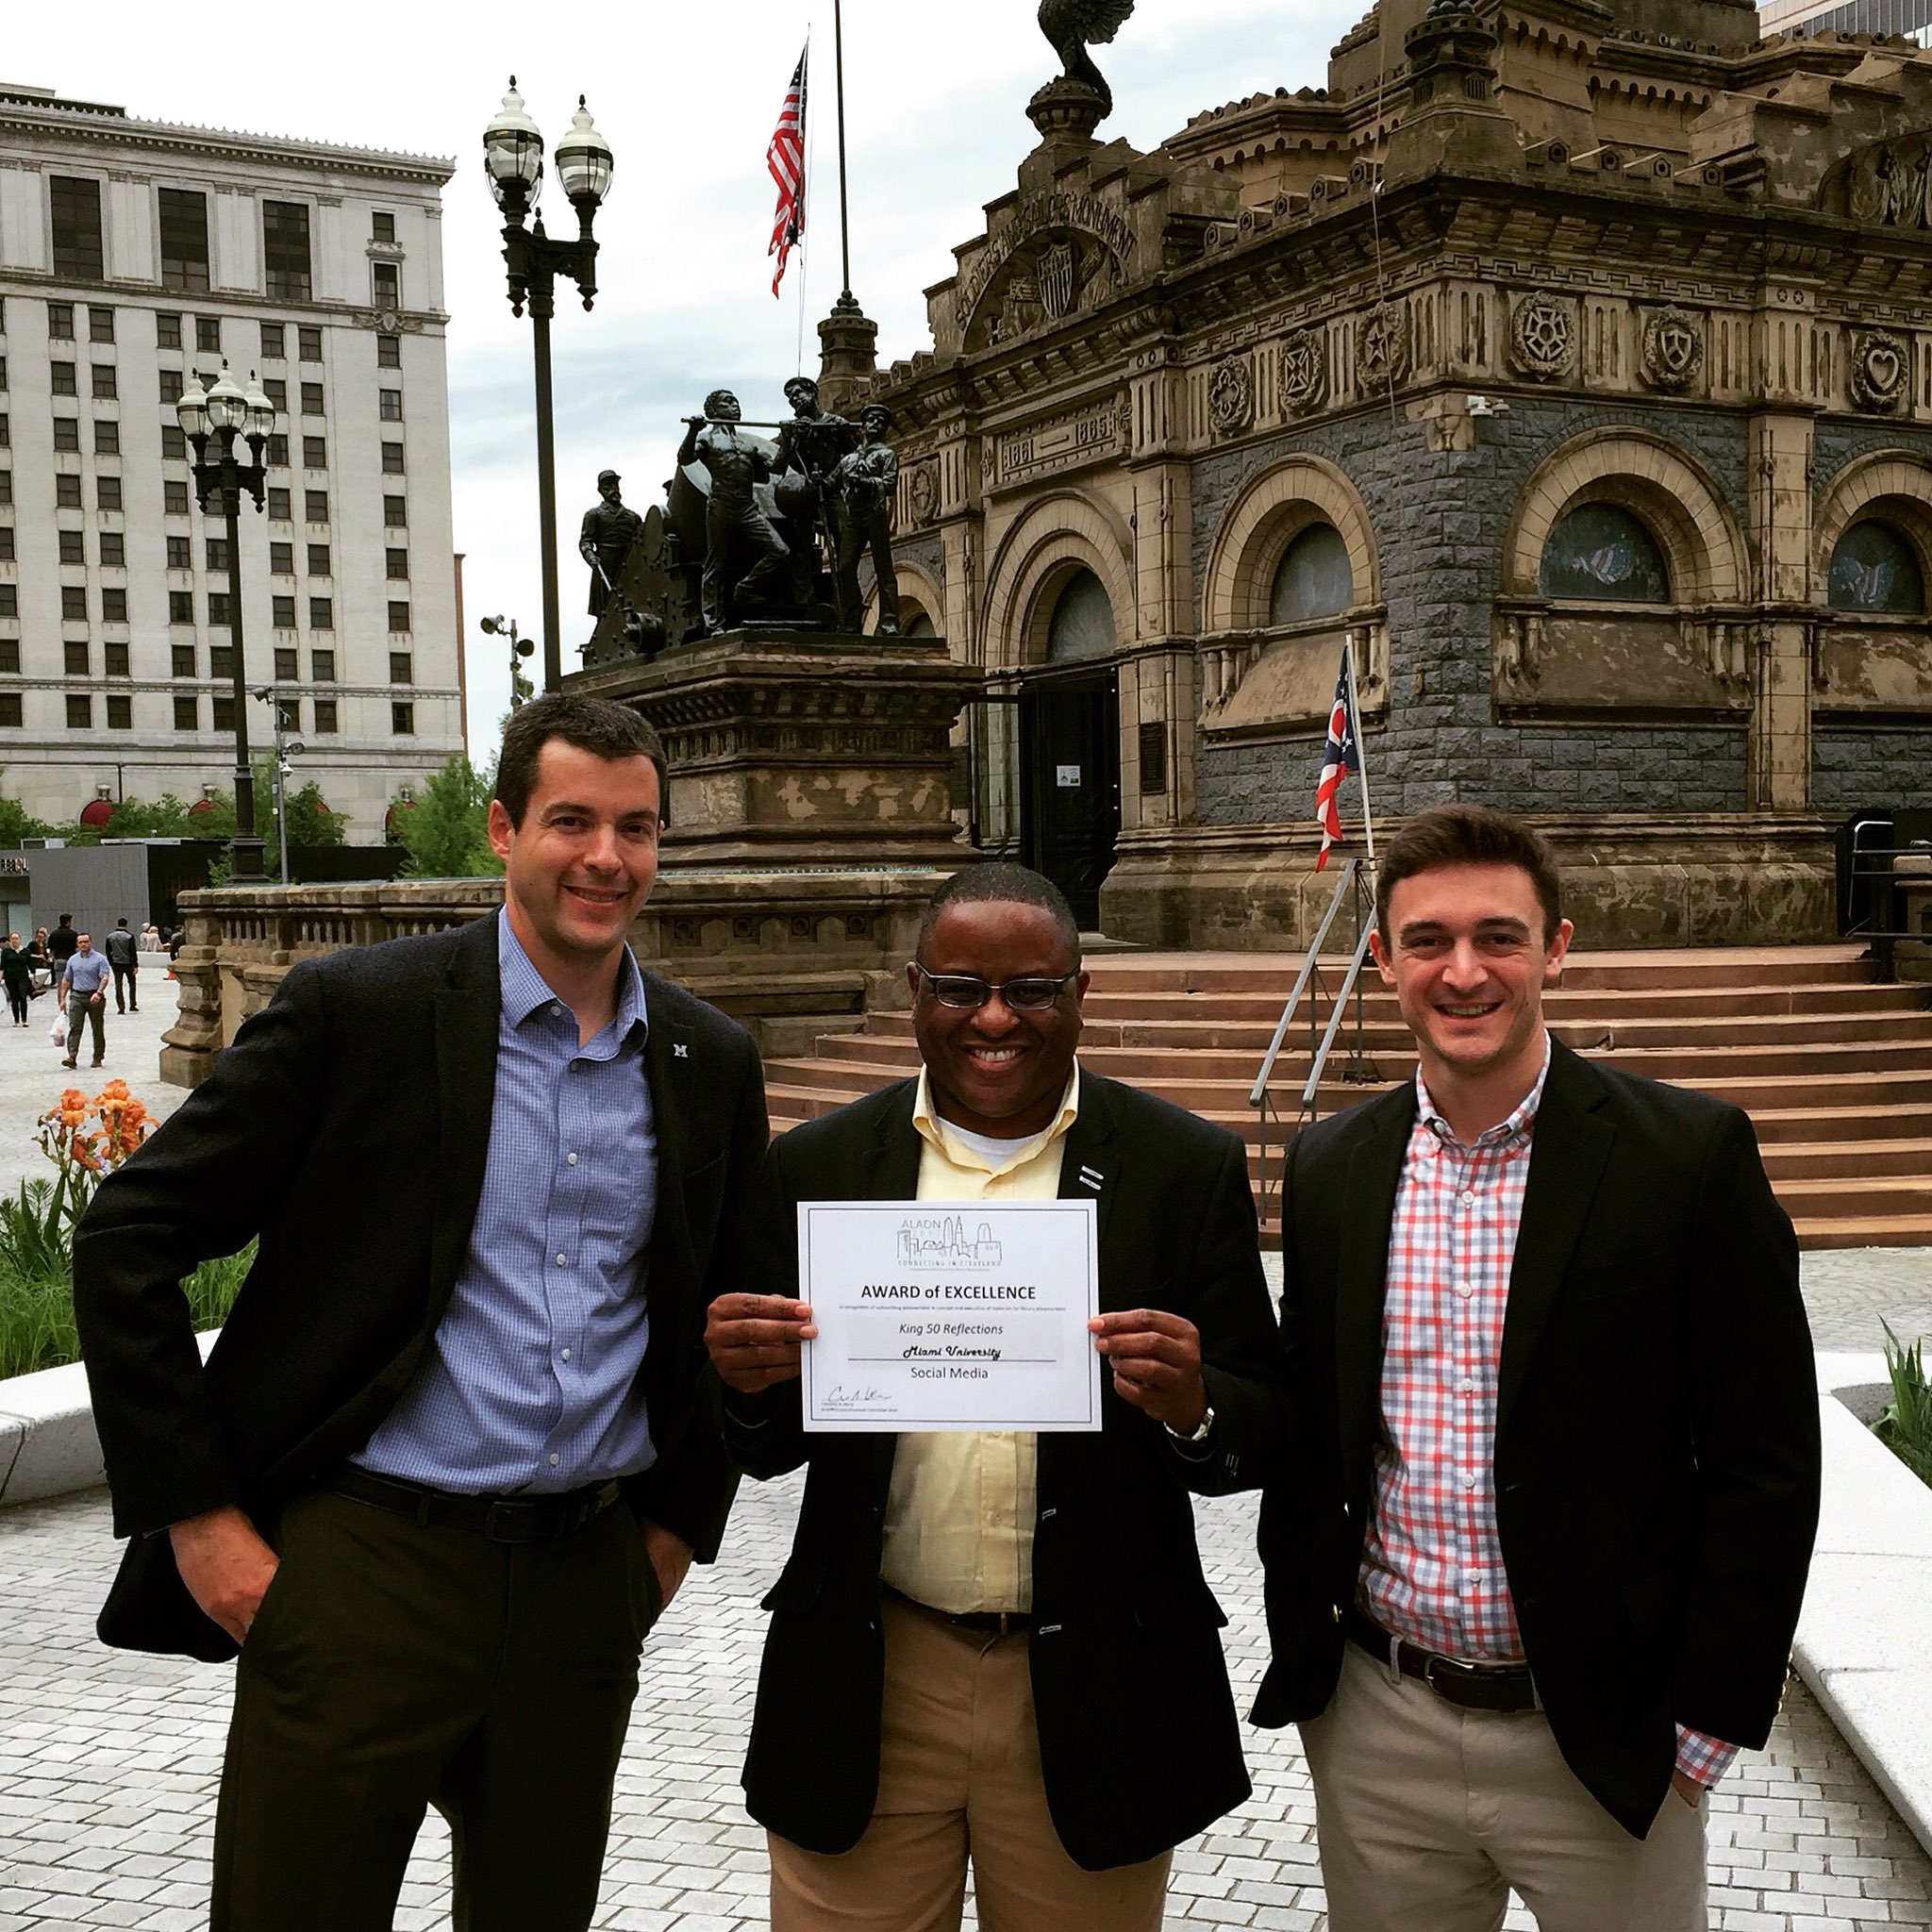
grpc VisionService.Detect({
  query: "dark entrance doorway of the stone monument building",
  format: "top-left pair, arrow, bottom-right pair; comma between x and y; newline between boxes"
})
1020,671 -> 1121,933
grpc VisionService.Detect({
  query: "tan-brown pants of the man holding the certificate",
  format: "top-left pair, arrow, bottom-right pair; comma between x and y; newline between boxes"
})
771,1598 -> 1169,1932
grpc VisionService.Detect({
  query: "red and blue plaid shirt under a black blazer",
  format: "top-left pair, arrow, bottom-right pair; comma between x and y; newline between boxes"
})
1360,1038 -> 1737,1787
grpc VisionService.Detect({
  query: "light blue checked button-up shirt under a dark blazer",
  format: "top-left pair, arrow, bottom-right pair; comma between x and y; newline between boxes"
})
356,914 -> 657,1495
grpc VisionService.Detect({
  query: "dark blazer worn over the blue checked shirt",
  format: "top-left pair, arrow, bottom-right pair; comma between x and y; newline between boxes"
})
74,916 -> 765,1659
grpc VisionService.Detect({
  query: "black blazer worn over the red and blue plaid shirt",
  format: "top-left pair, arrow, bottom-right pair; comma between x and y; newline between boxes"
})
1254,1045 -> 1818,1838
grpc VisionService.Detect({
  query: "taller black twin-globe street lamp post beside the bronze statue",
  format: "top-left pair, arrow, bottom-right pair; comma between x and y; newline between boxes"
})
483,87 -> 610,691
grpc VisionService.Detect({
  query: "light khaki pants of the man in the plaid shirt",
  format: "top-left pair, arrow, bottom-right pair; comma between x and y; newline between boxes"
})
1300,1644 -> 1706,1932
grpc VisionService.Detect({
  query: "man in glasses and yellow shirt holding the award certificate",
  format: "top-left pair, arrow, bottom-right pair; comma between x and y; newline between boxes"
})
708,866 -> 1283,1932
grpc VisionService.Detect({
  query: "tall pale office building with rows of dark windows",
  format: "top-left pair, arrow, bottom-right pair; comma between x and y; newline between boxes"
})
0,85 -> 464,839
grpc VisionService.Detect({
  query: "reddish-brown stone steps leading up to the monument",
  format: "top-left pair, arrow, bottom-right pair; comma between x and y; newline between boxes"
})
765,944 -> 1932,1248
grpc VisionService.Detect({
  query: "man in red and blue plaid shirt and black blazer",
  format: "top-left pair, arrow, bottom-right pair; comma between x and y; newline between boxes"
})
1254,806 -> 1818,1932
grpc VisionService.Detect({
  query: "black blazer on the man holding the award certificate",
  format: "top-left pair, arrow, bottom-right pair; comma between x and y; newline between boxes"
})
726,1074 -> 1283,1870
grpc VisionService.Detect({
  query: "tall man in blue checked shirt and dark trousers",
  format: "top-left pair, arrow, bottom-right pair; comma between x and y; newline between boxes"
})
74,695 -> 765,1932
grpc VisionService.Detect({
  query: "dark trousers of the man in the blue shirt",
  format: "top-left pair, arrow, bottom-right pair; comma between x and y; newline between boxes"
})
208,1491 -> 662,1932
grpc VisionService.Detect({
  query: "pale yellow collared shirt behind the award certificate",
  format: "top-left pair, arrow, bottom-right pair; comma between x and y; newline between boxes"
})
879,1066 -> 1080,1613
